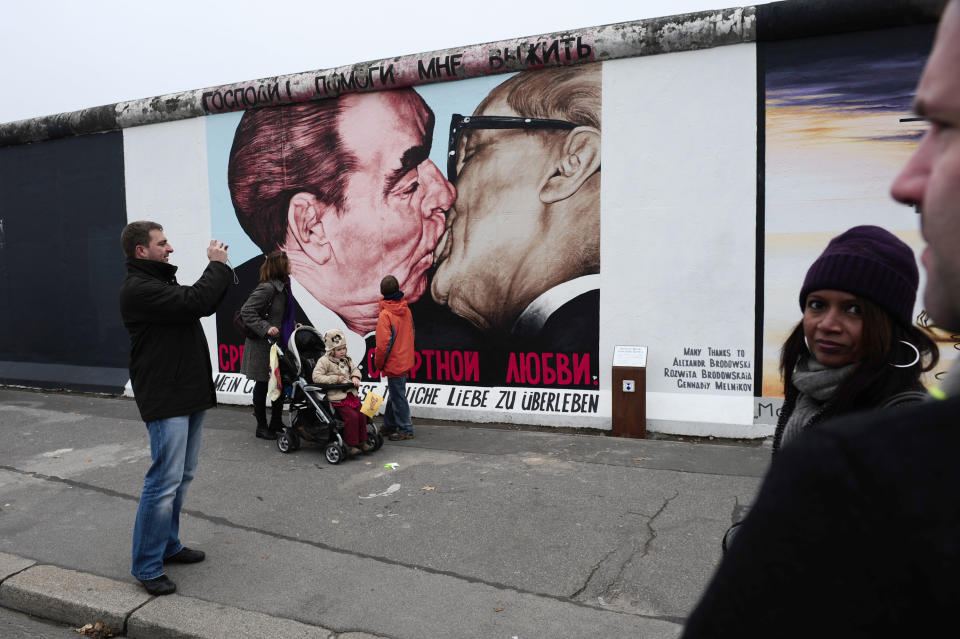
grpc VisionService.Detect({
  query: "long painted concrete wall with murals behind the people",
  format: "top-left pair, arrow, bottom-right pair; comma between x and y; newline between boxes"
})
0,0 -> 955,437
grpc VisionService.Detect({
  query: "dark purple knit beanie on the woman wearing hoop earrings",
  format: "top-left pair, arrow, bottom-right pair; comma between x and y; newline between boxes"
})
800,225 -> 920,326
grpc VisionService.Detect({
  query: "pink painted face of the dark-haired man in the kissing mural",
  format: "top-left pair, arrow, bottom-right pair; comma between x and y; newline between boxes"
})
323,90 -> 456,314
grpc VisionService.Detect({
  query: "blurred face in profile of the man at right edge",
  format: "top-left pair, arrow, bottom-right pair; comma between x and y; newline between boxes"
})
891,2 -> 960,330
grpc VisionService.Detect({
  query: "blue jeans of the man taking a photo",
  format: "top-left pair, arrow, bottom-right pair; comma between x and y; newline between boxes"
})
130,411 -> 204,579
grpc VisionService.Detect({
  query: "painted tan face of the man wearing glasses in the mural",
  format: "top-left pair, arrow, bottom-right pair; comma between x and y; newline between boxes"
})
431,98 -> 563,328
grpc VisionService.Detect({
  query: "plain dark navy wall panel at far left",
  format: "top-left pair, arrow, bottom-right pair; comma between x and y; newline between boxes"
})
0,132 -> 128,377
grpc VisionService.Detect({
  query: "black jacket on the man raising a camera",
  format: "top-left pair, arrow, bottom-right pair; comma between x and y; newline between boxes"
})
120,259 -> 231,422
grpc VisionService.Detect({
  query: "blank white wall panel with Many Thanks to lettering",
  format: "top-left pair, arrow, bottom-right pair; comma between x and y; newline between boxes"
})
600,44 -> 757,436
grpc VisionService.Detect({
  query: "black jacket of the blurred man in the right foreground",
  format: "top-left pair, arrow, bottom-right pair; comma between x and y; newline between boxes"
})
683,397 -> 960,639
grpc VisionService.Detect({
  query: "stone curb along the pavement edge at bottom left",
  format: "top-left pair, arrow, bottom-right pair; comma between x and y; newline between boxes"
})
0,553 -> 380,639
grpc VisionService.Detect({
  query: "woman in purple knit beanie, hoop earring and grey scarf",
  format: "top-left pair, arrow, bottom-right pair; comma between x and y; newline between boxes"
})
773,226 -> 939,454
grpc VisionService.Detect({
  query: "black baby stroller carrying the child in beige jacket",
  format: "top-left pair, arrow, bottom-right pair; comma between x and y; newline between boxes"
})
277,326 -> 383,464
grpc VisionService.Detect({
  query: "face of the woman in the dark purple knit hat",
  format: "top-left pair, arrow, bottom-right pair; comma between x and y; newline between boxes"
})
803,289 -> 863,368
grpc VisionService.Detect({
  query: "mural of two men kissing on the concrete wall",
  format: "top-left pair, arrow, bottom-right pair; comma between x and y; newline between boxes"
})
207,64 -> 602,412
